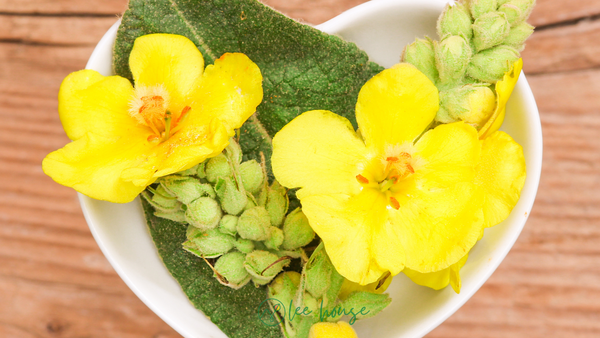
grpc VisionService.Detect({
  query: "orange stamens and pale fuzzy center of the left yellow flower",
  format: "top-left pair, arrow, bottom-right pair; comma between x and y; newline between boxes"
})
129,86 -> 191,142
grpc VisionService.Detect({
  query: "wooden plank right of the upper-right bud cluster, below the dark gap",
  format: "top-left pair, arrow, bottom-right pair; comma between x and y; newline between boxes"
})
522,19 -> 600,74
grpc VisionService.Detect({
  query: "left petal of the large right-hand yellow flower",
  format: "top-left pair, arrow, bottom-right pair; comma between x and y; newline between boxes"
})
271,110 -> 367,198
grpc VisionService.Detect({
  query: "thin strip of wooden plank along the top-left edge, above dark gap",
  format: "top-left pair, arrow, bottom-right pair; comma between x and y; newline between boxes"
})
0,0 -> 128,15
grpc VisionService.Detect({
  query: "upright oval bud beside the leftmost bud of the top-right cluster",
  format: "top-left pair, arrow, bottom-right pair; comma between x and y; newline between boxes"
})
434,35 -> 472,84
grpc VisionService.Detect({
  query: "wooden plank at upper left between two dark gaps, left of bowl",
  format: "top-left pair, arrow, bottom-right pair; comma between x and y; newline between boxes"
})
0,15 -> 117,46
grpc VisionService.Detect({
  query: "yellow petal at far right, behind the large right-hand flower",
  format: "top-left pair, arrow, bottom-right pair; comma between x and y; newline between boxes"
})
475,131 -> 526,227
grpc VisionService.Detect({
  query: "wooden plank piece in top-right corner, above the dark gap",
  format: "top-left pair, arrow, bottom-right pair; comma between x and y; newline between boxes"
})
529,0 -> 600,26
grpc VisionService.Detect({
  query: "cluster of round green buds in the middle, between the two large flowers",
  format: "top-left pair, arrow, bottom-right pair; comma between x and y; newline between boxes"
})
143,140 -> 315,289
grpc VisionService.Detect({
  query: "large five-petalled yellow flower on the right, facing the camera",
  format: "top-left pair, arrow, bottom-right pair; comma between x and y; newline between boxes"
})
272,64 -> 483,285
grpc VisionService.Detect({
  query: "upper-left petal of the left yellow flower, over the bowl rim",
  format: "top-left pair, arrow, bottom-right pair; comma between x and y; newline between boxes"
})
58,70 -> 143,140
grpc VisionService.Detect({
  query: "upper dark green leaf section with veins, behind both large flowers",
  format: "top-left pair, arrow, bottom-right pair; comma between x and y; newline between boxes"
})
114,0 -> 383,174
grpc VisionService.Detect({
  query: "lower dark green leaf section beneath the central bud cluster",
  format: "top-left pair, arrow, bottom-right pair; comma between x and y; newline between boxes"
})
142,200 -> 282,338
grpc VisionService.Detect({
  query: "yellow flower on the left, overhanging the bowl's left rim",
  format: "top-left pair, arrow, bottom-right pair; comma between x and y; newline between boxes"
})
42,34 -> 262,203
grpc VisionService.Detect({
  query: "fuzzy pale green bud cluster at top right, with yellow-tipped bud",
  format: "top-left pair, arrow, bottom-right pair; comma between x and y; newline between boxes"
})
402,0 -> 535,128
